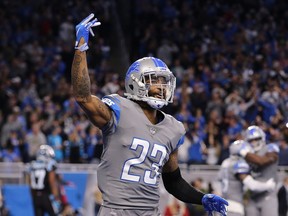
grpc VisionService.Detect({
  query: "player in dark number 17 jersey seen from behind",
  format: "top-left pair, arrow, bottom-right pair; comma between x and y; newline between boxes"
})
28,145 -> 60,216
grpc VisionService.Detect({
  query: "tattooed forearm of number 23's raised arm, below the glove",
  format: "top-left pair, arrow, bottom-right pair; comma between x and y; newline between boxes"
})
71,53 -> 91,102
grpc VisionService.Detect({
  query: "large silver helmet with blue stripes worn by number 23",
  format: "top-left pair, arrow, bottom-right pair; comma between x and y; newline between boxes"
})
125,57 -> 176,109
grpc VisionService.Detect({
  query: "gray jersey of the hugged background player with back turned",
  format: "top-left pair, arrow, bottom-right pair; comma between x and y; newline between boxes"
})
218,157 -> 249,203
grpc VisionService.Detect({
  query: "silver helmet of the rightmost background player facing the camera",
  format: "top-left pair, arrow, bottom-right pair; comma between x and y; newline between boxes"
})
245,125 -> 266,152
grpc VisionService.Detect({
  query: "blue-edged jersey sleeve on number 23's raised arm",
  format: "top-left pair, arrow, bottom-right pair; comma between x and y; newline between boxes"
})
102,95 -> 121,134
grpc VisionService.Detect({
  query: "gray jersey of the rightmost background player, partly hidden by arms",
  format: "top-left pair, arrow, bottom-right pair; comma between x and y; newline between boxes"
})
250,143 -> 279,199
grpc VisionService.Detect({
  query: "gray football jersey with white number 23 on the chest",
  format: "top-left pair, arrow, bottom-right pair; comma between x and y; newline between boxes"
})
97,95 -> 185,209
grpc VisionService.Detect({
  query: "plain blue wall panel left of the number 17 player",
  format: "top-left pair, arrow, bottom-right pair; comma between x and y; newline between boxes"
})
2,184 -> 34,216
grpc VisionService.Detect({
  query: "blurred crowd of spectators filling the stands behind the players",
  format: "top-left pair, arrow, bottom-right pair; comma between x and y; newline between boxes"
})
0,0 -> 288,165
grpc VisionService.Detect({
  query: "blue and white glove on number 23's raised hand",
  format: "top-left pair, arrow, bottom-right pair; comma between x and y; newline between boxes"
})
75,13 -> 101,52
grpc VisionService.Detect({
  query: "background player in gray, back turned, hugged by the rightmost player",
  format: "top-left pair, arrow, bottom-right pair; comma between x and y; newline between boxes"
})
219,140 -> 276,216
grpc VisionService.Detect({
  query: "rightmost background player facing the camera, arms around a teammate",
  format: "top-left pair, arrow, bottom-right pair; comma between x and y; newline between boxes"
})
239,125 -> 279,216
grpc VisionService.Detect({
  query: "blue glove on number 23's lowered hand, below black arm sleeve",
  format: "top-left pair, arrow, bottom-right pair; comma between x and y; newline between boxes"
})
202,194 -> 229,216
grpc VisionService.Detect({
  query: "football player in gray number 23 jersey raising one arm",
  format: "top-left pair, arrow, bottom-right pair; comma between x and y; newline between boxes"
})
72,14 -> 228,216
